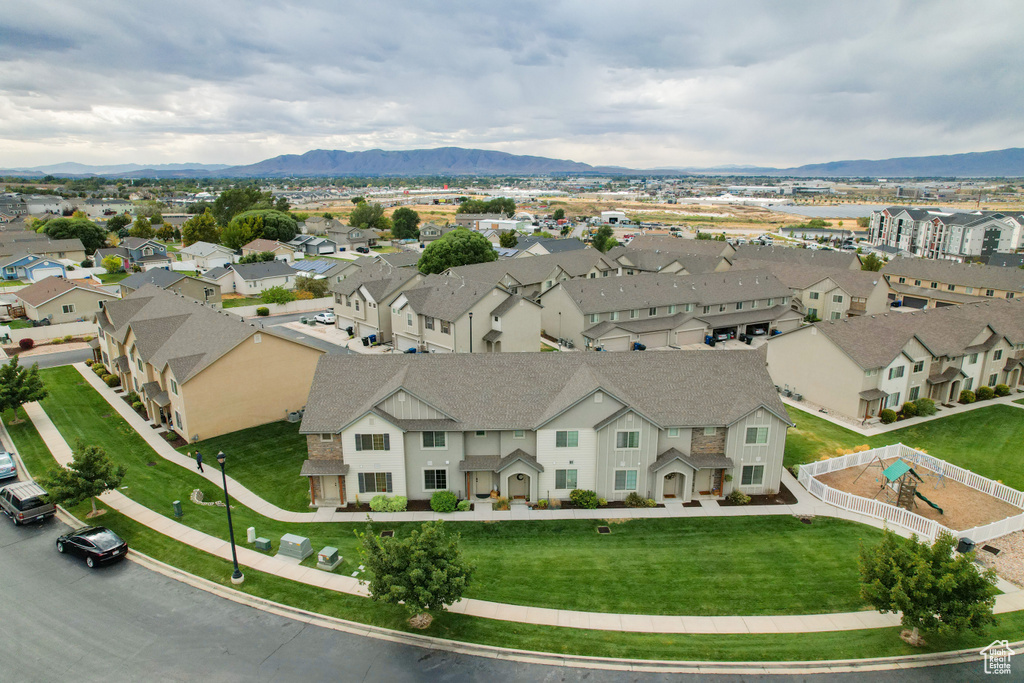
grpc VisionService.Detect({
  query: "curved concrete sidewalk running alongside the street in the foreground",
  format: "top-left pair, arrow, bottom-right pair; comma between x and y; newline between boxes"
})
25,385 -> 1024,634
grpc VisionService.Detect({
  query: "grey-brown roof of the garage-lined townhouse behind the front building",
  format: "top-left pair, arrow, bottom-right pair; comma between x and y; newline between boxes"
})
541,270 -> 791,314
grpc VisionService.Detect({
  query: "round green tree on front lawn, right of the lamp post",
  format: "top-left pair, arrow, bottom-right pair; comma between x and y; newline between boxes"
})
358,521 -> 475,628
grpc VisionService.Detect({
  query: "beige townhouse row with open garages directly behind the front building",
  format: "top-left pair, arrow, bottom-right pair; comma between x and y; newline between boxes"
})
540,270 -> 803,351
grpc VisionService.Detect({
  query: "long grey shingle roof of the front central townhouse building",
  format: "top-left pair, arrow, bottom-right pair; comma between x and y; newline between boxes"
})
300,350 -> 790,433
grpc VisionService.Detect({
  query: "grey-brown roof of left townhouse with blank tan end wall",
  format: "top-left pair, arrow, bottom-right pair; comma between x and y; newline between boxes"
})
96,285 -> 319,383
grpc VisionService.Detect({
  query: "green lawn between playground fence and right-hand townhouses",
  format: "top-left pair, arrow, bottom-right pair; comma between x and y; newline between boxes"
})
785,404 -> 1024,489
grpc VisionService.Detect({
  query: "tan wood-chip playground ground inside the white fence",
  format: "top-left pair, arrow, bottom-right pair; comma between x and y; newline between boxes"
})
817,460 -> 1022,531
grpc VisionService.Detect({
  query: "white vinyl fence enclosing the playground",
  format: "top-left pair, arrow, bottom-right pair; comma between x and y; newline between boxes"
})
799,443 -> 1024,543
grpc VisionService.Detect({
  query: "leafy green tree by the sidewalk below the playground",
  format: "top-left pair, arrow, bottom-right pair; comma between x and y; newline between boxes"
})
860,530 -> 996,645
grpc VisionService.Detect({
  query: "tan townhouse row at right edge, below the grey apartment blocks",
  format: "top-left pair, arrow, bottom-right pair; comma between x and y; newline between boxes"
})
881,257 -> 1024,308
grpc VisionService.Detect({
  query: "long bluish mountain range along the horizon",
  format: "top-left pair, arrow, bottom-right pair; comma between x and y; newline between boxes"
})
6,147 -> 1024,178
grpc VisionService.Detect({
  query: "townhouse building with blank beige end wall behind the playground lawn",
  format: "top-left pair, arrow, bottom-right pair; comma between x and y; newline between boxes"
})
768,299 -> 1024,419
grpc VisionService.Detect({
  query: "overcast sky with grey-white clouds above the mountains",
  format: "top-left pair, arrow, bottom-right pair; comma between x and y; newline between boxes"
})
0,0 -> 1024,168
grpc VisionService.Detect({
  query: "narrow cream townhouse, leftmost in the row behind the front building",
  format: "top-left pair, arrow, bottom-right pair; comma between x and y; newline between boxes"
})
331,260 -> 423,342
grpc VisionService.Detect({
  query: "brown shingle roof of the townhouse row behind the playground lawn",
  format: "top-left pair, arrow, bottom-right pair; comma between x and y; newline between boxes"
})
785,299 -> 1024,370
